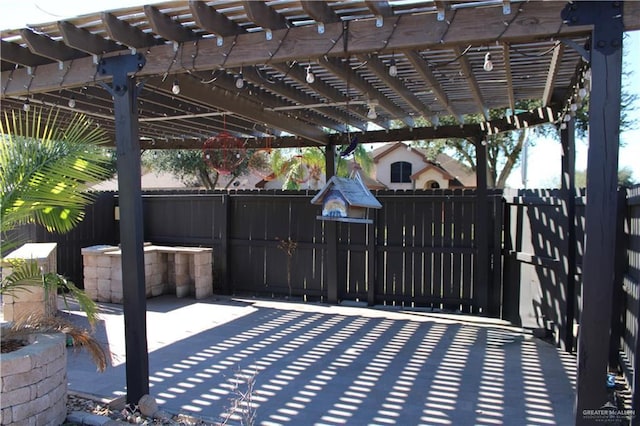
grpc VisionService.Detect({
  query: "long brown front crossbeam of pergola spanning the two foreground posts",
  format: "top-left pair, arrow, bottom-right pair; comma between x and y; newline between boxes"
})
2,2 -> 604,96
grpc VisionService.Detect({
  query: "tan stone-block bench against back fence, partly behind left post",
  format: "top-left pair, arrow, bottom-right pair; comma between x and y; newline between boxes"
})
82,244 -> 213,303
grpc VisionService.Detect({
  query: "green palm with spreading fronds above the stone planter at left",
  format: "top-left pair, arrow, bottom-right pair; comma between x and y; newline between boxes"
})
0,108 -> 111,366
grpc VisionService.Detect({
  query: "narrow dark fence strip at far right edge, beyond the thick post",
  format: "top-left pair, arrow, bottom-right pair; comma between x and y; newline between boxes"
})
620,185 -> 640,413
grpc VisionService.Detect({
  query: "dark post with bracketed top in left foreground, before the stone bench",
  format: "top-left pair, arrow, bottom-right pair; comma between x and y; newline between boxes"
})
98,54 -> 149,404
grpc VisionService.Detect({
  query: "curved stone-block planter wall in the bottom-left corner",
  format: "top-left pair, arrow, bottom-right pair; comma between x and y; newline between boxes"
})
0,333 -> 67,426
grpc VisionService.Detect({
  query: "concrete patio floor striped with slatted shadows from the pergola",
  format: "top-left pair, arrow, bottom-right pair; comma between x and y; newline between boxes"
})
62,296 -> 575,426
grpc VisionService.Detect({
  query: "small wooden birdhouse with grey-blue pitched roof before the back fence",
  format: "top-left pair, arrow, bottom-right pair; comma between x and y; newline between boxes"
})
311,173 -> 382,223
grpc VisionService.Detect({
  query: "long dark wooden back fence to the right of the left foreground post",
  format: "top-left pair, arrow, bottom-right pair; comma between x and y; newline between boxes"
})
143,190 -> 502,312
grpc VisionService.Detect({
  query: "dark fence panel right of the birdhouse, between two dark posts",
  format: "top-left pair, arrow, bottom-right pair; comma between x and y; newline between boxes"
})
375,190 -> 482,312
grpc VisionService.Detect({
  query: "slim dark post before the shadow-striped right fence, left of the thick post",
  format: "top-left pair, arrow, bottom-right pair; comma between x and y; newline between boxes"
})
560,120 -> 577,352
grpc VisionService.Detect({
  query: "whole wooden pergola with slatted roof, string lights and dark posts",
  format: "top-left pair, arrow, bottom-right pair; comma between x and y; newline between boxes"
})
0,0 -> 640,423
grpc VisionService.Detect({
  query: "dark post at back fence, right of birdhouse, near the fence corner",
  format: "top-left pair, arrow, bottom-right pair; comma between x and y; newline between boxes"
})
473,137 -> 495,315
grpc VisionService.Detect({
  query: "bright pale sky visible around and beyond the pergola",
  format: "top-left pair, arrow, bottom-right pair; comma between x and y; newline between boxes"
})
0,0 -> 640,188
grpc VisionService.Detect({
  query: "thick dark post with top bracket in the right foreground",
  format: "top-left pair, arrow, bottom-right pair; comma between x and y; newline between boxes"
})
562,1 -> 624,425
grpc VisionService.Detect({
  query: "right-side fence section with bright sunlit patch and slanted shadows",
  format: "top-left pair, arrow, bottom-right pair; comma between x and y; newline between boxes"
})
503,190 -> 584,350
